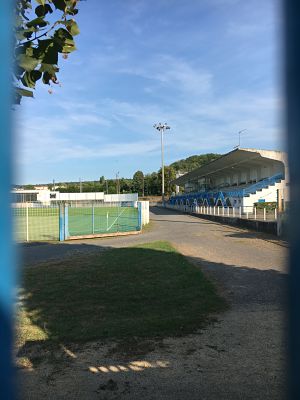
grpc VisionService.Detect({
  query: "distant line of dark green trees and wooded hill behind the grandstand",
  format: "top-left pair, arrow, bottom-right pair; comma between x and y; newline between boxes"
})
23,153 -> 221,196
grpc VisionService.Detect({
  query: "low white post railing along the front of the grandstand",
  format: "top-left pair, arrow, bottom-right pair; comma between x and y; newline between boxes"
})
165,204 -> 277,221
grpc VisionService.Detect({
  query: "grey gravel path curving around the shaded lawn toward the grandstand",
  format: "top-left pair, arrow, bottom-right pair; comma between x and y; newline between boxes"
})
21,208 -> 286,400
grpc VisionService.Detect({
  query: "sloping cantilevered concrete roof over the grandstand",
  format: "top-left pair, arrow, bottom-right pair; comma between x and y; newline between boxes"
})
172,148 -> 286,186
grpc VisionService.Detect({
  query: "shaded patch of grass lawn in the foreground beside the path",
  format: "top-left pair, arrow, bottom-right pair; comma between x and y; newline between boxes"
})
17,242 -> 226,345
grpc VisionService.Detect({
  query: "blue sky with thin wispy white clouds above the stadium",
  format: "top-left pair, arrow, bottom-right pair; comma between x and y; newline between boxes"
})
15,0 -> 284,184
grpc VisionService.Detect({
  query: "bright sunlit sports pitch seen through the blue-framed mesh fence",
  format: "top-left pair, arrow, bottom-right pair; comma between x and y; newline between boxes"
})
13,207 -> 138,241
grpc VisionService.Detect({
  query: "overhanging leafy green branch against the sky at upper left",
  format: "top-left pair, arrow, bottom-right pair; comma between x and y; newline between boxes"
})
14,0 -> 80,104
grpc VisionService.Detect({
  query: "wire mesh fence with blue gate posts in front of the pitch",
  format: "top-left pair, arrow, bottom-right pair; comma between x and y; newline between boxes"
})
12,202 -> 141,242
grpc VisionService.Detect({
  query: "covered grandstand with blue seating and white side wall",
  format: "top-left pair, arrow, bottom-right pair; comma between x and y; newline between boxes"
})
169,148 -> 288,209
